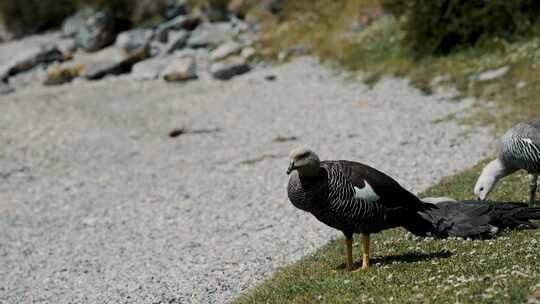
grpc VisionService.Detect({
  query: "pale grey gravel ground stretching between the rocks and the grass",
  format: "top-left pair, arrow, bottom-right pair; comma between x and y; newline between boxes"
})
0,58 -> 493,303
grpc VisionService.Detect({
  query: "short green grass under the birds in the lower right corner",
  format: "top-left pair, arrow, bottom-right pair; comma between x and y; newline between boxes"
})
234,162 -> 540,304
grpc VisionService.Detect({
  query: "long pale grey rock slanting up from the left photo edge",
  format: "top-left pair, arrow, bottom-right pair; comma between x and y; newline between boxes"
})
0,45 -> 66,81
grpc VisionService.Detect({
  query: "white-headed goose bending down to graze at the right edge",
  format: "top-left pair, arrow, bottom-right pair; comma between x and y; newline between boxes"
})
474,120 -> 540,206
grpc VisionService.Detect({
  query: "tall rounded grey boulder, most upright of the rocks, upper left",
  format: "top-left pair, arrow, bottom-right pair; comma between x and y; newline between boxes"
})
74,11 -> 114,52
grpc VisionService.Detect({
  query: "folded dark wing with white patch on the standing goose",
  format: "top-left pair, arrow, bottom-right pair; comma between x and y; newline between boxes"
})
322,160 -> 427,210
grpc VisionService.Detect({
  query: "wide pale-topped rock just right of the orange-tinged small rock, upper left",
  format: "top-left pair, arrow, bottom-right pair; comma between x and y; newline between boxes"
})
78,46 -> 148,80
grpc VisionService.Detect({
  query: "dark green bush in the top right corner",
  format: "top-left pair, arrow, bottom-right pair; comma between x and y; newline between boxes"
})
381,0 -> 540,55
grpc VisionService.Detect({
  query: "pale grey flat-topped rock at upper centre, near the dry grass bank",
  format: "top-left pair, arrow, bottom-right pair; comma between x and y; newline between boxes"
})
187,22 -> 232,48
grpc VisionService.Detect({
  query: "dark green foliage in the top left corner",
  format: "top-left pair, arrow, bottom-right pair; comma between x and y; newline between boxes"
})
0,0 -> 76,36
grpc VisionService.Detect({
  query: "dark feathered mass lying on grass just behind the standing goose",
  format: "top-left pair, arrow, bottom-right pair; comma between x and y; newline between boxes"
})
403,200 -> 540,238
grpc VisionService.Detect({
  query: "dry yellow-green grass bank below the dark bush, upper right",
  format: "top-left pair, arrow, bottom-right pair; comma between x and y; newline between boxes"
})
258,0 -> 540,134
